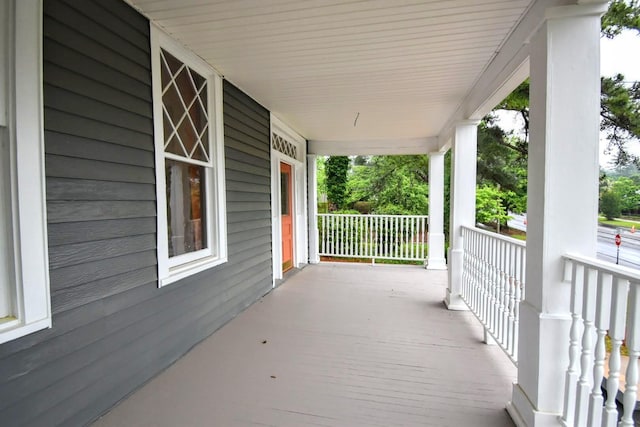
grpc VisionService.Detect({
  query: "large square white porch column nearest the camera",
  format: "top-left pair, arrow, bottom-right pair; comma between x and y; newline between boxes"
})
507,3 -> 606,426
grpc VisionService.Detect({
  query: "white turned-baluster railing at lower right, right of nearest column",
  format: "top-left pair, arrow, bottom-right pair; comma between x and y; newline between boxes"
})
562,255 -> 640,427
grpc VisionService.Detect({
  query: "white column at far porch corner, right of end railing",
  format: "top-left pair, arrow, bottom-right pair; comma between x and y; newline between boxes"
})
427,151 -> 447,270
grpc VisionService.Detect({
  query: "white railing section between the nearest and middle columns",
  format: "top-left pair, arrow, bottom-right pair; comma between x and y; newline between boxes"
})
462,227 -> 526,363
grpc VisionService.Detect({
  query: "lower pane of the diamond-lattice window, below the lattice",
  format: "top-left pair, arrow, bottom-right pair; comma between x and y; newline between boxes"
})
165,160 -> 207,257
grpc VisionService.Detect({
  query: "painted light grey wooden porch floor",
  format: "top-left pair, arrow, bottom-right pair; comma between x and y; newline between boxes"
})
94,264 -> 516,427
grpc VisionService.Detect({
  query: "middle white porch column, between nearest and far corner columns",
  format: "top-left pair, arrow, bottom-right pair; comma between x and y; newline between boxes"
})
444,120 -> 478,310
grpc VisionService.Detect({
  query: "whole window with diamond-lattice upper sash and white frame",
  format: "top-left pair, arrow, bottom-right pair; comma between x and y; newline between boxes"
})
152,30 -> 226,285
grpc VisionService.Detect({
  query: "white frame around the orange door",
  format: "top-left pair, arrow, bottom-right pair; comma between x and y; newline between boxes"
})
270,114 -> 309,287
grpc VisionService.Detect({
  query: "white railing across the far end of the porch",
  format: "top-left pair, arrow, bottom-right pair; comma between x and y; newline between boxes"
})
318,214 -> 427,261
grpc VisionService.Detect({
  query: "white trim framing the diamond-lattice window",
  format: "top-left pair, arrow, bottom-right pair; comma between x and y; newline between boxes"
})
151,23 -> 228,287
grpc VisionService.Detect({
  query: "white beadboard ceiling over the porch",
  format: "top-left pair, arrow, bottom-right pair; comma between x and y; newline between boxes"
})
129,0 -> 531,141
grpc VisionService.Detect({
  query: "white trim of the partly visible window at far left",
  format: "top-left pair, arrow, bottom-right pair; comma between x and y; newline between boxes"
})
0,0 -> 51,344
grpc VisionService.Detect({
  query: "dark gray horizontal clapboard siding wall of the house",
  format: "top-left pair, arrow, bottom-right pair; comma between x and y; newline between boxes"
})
0,0 -> 272,427
